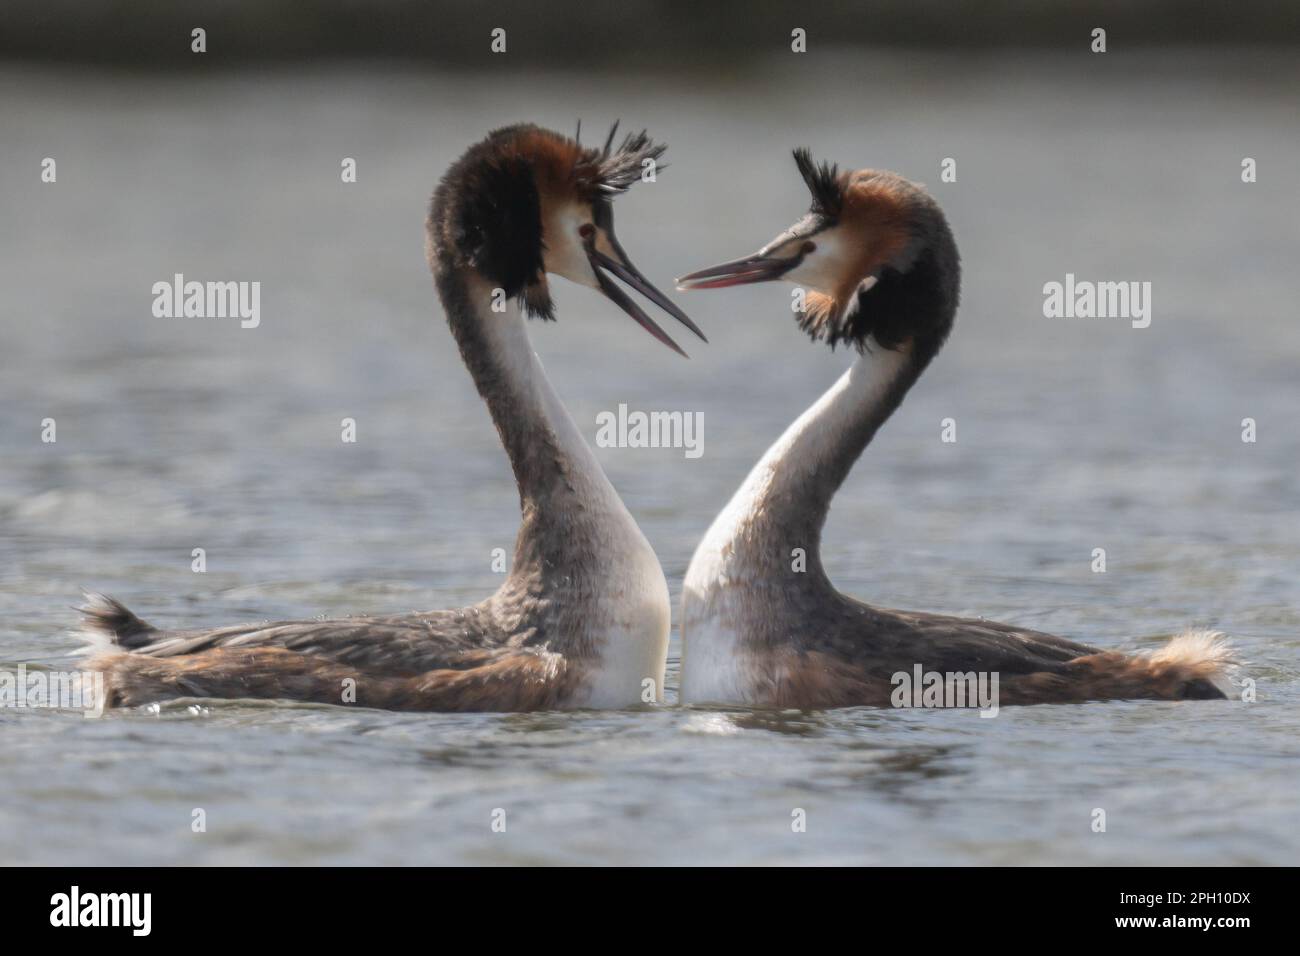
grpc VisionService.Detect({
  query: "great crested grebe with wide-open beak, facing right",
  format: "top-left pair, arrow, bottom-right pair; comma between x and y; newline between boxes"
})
81,124 -> 703,710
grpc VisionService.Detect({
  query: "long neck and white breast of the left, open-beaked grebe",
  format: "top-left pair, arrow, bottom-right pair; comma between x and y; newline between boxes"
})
443,278 -> 671,706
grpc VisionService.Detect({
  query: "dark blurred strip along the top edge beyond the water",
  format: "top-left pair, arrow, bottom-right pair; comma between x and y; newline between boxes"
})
0,0 -> 1300,64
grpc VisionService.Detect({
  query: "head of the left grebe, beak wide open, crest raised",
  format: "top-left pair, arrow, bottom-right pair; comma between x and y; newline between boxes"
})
428,124 -> 705,355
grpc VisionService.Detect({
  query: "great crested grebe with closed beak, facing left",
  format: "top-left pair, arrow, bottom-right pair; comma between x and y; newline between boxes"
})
679,150 -> 1230,708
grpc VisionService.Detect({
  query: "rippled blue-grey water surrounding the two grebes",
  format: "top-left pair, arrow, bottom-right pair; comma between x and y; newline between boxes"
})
0,52 -> 1300,864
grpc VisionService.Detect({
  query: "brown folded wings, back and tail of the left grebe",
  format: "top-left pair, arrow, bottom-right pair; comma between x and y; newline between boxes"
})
81,593 -> 594,711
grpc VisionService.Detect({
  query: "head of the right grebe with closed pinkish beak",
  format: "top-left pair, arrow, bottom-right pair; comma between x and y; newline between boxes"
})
677,150 -> 961,350
